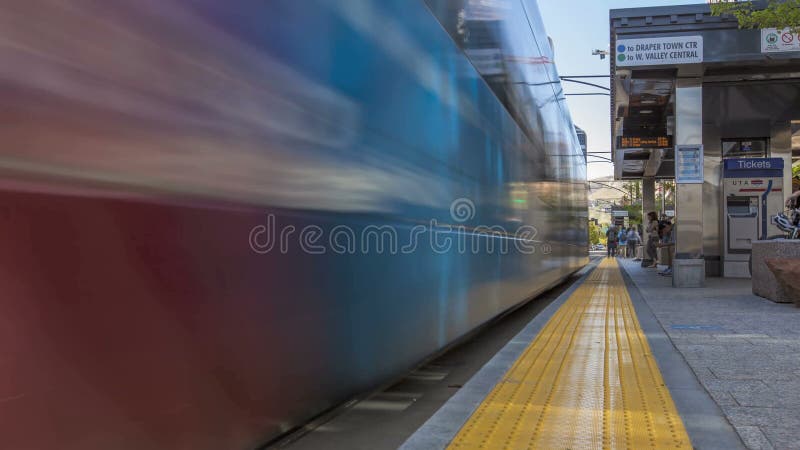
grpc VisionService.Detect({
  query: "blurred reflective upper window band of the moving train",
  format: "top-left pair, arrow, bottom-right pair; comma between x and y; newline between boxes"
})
425,0 -> 586,184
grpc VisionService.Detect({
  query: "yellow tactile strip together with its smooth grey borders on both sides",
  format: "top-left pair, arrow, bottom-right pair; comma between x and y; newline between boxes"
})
402,259 -> 743,449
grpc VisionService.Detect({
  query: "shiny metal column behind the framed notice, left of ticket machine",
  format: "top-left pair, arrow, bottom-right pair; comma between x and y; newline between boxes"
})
672,78 -> 706,287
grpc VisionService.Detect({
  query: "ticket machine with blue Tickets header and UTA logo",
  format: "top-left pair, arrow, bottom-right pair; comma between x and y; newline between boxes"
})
722,158 -> 784,278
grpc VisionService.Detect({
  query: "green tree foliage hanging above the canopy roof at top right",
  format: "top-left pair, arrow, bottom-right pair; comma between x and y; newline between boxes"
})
709,0 -> 800,33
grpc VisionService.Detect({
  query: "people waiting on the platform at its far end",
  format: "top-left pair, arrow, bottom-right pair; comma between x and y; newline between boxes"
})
606,211 -> 675,276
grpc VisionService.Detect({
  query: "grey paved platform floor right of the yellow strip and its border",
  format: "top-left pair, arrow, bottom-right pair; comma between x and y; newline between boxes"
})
620,259 -> 800,450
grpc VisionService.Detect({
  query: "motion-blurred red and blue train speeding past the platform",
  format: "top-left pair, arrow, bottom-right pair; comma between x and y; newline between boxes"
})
0,0 -> 587,450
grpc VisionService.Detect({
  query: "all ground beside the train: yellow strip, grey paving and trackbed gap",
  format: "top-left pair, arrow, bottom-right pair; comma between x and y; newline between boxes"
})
291,258 -> 800,450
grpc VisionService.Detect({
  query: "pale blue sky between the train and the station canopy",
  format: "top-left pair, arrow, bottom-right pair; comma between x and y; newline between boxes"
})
538,0 -> 707,179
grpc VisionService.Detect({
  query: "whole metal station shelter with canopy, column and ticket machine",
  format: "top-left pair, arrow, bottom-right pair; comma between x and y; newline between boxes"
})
610,2 -> 800,287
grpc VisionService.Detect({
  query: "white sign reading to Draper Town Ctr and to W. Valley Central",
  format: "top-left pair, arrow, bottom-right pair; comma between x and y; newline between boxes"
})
616,36 -> 703,67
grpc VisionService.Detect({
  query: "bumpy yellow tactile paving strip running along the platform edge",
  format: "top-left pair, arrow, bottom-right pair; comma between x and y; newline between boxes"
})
449,259 -> 692,450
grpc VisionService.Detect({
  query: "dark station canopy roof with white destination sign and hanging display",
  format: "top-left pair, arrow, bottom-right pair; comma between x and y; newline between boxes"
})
610,5 -> 800,179
